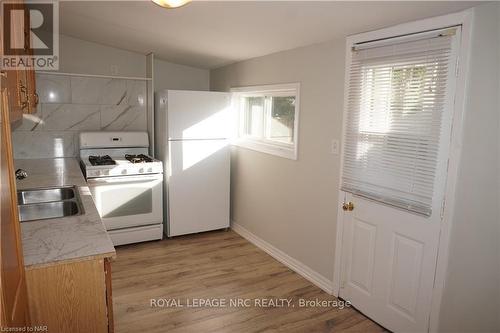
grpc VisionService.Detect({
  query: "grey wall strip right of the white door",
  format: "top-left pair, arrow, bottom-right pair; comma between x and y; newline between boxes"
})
439,3 -> 500,332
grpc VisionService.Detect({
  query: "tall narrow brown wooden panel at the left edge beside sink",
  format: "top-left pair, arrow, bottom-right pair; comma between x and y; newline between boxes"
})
0,73 -> 29,331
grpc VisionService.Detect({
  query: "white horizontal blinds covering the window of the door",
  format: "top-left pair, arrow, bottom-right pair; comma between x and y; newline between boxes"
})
342,28 -> 456,216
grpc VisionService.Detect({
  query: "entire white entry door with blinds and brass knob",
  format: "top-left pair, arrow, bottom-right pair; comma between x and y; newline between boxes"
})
339,27 -> 460,332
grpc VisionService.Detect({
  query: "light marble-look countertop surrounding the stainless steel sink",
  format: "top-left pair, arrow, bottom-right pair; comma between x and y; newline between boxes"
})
14,158 -> 115,269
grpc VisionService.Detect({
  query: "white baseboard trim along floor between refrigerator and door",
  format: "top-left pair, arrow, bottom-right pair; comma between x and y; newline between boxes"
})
231,221 -> 333,295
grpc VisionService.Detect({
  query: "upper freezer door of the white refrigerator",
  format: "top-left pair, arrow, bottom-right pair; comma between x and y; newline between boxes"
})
168,90 -> 234,140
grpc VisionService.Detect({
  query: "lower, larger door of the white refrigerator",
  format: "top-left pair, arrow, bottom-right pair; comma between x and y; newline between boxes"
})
167,140 -> 230,237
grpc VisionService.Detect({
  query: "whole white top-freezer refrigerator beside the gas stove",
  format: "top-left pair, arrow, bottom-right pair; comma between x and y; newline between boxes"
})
154,90 -> 233,237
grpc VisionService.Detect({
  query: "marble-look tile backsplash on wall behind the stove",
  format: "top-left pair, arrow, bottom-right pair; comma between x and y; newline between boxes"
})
12,74 -> 147,158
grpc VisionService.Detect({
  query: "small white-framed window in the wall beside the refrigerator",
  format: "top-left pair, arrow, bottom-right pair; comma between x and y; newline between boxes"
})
231,84 -> 299,159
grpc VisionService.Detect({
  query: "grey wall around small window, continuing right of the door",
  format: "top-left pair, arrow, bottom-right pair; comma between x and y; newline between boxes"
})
210,3 -> 500,332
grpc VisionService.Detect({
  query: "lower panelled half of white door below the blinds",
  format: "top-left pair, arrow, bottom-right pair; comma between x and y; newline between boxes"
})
339,194 -> 440,332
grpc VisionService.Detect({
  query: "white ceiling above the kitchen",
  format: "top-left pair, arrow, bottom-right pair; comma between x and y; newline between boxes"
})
60,0 -> 478,68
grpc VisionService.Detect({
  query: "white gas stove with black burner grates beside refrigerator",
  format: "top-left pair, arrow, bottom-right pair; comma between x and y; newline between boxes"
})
80,132 -> 163,245
